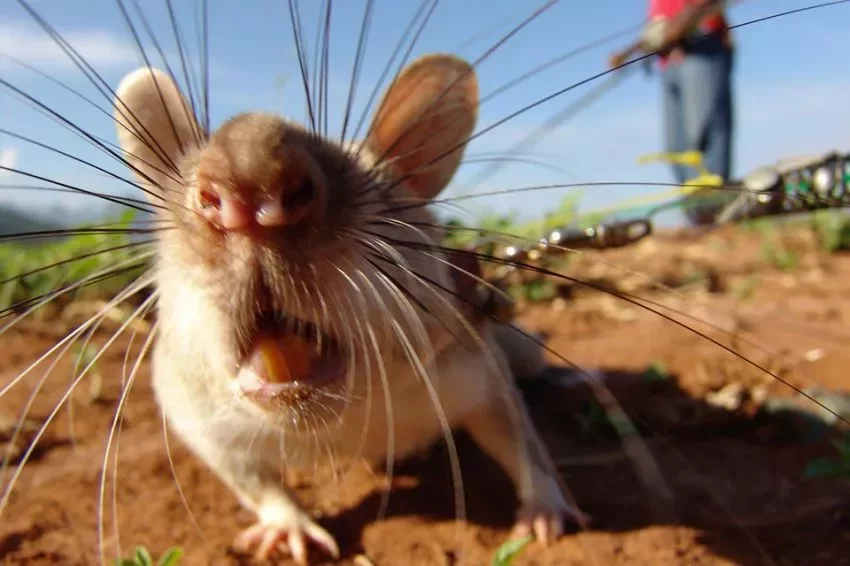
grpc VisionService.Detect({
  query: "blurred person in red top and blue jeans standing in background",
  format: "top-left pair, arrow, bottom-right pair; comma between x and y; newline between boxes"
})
609,0 -> 735,224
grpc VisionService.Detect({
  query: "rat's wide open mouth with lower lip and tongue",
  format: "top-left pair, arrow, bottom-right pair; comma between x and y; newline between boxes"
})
237,313 -> 345,401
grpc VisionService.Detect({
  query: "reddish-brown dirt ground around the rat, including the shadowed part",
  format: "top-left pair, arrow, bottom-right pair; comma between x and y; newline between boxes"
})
0,224 -> 850,566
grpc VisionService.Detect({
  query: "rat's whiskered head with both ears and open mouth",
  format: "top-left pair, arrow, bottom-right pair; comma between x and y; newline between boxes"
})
115,55 -> 478,426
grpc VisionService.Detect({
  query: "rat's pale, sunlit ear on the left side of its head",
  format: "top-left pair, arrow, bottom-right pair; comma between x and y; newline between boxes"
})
113,67 -> 201,200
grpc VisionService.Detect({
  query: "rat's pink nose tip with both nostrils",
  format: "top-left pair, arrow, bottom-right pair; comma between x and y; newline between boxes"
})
197,181 -> 315,231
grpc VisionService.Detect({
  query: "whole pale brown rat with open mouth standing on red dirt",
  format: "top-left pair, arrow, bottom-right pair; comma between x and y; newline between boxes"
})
116,56 -> 573,561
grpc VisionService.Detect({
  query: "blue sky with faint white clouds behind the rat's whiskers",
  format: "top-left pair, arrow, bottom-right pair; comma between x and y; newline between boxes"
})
0,0 -> 850,229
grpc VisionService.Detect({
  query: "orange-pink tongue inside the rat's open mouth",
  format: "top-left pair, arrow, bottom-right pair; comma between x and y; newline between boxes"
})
239,332 -> 315,384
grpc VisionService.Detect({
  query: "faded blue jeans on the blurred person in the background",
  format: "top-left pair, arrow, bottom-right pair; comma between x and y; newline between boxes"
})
662,36 -> 734,224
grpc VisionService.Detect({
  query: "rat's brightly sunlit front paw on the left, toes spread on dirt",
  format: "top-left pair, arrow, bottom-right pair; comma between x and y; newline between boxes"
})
233,508 -> 339,564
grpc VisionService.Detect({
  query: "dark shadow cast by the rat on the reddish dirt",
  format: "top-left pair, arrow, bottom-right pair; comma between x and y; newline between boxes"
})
314,369 -> 850,566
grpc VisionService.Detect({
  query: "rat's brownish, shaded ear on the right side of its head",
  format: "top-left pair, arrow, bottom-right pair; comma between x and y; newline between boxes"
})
366,54 -> 478,199
